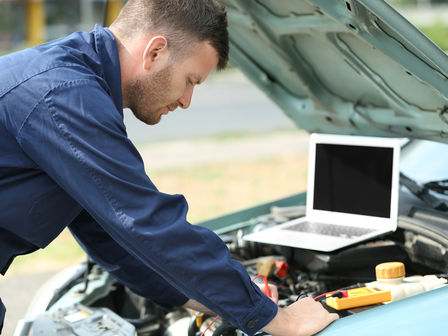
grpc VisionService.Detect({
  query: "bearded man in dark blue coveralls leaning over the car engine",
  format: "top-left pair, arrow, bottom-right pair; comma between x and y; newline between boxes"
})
0,0 -> 337,336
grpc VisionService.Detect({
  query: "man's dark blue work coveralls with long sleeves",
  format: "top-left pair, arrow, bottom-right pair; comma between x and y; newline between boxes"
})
0,26 -> 277,334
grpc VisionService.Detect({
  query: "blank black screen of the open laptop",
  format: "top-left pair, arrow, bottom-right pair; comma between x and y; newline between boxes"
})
313,143 -> 394,218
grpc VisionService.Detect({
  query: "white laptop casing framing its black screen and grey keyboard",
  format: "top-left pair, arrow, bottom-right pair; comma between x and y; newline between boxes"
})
244,134 -> 402,251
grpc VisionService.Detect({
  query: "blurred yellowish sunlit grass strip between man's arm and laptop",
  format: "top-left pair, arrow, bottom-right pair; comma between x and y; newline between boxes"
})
151,155 -> 307,223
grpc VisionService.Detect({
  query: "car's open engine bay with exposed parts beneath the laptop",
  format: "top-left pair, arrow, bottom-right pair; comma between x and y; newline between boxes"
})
20,201 -> 448,336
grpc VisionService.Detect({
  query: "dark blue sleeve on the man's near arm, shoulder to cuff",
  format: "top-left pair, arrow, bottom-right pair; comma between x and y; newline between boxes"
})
17,80 -> 277,335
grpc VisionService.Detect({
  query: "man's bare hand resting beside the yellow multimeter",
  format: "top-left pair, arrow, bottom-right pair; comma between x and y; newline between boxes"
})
263,297 -> 339,336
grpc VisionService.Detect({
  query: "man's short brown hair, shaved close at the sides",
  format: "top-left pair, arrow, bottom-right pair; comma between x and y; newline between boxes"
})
112,0 -> 229,70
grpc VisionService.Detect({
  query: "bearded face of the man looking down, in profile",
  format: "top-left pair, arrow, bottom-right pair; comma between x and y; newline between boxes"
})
127,41 -> 218,125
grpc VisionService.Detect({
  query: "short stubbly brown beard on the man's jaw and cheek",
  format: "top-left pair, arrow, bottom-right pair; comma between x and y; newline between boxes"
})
125,66 -> 177,125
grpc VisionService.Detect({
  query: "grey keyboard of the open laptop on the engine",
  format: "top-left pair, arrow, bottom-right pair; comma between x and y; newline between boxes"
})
283,222 -> 375,238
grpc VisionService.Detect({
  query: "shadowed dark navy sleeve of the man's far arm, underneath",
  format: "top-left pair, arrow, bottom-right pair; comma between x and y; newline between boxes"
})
69,211 -> 188,309
